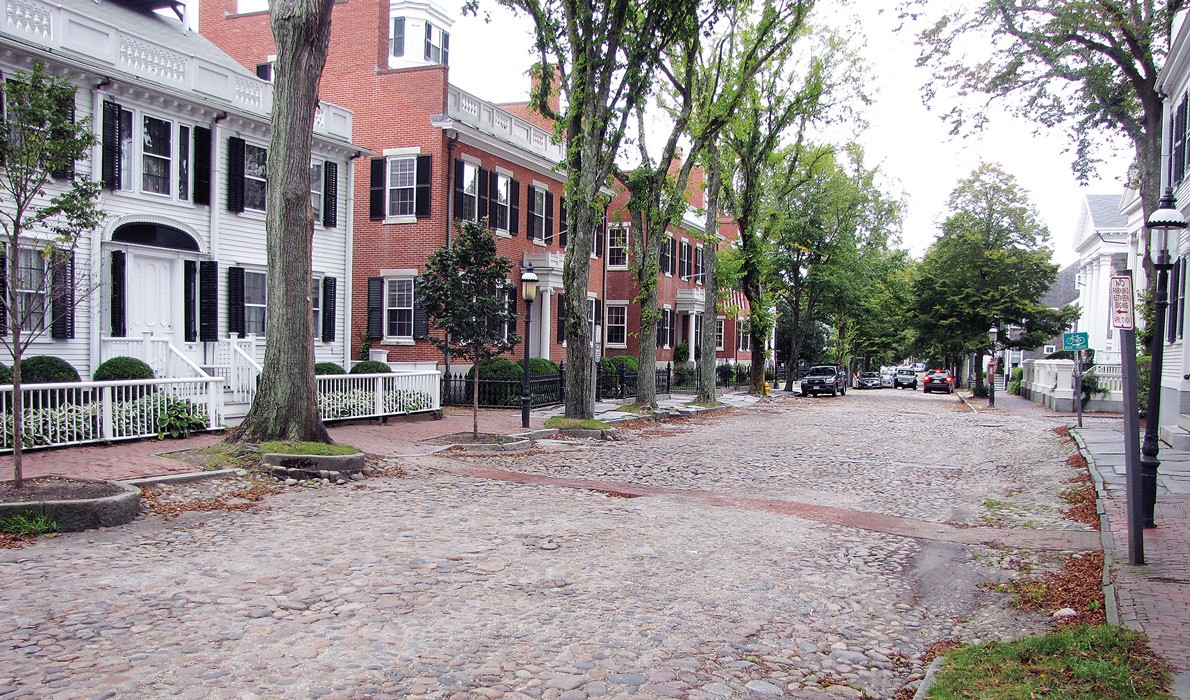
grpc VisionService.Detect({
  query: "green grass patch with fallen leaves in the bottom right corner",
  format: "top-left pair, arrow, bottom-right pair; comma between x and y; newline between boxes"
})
927,625 -> 1173,700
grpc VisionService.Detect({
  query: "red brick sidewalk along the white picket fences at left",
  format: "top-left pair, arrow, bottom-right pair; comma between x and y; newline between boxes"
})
0,407 -> 541,480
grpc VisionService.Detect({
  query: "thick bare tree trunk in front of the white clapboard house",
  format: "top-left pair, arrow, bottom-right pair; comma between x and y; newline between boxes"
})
231,0 -> 333,442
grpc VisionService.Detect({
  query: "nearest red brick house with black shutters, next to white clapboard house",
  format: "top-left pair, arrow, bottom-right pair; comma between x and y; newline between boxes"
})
200,0 -> 605,367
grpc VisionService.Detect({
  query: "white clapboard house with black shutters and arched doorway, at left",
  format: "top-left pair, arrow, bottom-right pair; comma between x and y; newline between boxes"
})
0,0 -> 362,419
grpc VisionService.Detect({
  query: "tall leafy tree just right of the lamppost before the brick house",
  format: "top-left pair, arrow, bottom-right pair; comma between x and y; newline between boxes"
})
465,0 -> 699,418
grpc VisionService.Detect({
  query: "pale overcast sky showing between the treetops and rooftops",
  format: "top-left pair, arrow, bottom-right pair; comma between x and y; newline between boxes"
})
446,0 -> 1131,264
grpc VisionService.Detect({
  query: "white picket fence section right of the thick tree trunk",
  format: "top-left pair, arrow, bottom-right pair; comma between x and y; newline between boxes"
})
315,370 -> 441,420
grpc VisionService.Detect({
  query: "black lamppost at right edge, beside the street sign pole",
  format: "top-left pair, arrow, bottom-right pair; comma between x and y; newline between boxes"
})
1140,188 -> 1186,527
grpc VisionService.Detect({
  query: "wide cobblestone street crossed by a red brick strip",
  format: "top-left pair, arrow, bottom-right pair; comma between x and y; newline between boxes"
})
0,389 -> 1097,700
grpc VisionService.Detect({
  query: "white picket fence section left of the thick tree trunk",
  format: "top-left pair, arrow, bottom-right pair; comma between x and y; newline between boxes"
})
0,376 -> 223,452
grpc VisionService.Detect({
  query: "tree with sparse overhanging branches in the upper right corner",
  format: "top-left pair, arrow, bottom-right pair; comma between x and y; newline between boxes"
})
903,0 -> 1185,270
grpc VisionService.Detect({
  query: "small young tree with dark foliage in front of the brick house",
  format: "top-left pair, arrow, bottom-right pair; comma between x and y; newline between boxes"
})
418,220 -> 520,438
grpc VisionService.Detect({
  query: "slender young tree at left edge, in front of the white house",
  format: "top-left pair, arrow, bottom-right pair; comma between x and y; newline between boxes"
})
0,63 -> 104,488
